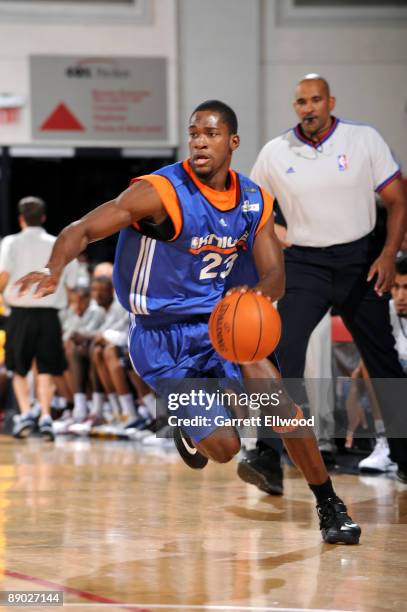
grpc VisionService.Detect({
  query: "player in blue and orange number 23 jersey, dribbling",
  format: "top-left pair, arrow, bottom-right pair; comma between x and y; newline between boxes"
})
18,100 -> 361,544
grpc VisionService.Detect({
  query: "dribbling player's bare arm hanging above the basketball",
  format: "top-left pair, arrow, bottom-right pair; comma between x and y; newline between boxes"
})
253,215 -> 285,302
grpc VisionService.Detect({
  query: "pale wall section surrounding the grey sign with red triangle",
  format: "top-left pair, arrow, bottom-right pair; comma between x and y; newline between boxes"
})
0,0 -> 178,146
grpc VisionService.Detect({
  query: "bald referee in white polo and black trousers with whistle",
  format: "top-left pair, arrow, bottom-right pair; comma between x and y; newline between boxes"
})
239,74 -> 407,490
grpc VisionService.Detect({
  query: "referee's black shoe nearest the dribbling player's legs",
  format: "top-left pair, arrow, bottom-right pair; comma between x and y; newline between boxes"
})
237,449 -> 283,495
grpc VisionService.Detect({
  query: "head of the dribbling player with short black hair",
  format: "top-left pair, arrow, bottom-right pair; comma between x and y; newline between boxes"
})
188,100 -> 240,179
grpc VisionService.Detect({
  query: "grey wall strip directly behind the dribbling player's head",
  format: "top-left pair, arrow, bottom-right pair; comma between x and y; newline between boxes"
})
179,0 -> 260,172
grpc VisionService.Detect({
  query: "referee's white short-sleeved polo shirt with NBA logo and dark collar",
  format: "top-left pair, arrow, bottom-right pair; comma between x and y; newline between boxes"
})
251,118 -> 400,247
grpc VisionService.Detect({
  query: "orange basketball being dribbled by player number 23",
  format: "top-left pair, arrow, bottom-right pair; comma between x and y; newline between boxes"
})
209,291 -> 281,363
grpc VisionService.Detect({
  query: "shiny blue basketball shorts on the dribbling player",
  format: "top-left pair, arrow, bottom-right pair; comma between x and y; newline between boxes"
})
129,315 -> 242,442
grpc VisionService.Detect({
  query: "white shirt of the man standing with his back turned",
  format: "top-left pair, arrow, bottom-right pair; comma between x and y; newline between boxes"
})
0,227 -> 78,309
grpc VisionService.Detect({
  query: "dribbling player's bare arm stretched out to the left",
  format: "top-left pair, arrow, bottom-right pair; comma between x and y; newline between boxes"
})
16,181 -> 166,297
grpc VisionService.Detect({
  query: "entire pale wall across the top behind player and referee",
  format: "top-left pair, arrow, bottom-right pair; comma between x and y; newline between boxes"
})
0,0 -> 407,172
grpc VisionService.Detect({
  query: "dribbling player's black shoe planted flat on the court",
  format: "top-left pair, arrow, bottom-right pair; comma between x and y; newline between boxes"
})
317,496 -> 362,544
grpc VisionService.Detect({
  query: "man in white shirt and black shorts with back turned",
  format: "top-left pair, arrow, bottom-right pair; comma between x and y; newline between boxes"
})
0,196 -> 77,440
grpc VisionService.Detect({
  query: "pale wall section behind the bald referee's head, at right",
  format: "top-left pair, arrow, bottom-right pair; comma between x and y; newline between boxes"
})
262,0 -> 407,167
